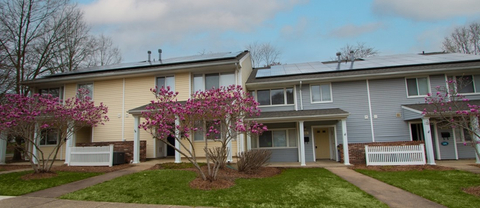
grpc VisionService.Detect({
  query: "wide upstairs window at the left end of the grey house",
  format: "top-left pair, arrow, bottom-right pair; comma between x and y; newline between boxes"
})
250,88 -> 294,105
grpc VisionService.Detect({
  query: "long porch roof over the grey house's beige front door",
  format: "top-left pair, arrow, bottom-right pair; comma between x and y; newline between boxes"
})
247,108 -> 350,123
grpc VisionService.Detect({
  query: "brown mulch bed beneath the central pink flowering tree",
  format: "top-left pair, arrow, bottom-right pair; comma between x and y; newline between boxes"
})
150,164 -> 283,190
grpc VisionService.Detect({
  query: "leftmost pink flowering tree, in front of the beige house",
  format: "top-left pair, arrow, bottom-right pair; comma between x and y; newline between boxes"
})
0,89 -> 108,173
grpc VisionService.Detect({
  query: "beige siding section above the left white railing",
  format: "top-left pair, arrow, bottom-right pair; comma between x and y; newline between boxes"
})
92,79 -> 123,142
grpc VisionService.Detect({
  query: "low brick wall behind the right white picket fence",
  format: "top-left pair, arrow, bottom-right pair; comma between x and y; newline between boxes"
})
338,141 -> 424,164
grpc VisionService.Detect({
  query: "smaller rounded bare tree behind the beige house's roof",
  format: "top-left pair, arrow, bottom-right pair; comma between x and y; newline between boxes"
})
87,34 -> 122,66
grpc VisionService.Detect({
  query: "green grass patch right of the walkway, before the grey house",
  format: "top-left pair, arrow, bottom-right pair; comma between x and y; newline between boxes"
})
356,169 -> 480,207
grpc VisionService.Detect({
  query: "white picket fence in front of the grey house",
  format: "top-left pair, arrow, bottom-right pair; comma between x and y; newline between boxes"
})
365,144 -> 426,166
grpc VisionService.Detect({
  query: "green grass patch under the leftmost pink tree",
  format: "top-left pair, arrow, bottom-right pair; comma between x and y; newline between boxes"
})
0,171 -> 102,196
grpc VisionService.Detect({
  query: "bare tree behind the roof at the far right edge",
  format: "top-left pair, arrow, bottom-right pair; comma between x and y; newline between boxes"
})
442,22 -> 480,55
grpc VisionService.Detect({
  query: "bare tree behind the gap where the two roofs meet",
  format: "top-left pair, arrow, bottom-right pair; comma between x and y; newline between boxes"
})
246,42 -> 282,67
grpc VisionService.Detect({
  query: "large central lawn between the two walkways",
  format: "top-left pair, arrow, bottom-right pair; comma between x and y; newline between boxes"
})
61,168 -> 387,207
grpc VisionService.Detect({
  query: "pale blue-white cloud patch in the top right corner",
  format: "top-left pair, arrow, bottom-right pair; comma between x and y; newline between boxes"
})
372,0 -> 480,21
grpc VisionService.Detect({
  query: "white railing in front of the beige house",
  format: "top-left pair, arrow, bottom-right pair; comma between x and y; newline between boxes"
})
68,144 -> 113,167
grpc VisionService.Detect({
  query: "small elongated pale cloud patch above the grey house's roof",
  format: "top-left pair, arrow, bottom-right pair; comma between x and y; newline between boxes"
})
329,22 -> 385,38
